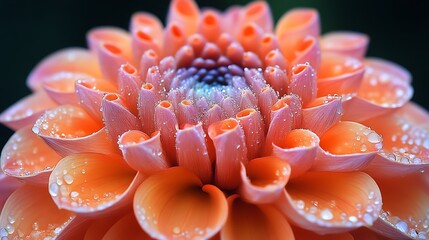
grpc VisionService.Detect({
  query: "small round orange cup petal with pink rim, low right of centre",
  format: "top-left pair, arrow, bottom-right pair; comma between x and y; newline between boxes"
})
239,156 -> 290,204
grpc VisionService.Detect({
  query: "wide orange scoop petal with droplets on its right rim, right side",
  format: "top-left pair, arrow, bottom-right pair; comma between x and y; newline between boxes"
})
312,122 -> 382,171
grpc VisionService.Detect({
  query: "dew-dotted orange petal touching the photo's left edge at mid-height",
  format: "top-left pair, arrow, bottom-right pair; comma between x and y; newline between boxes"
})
1,126 -> 61,183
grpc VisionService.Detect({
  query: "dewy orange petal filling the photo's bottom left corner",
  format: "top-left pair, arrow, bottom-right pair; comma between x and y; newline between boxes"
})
0,185 -> 78,239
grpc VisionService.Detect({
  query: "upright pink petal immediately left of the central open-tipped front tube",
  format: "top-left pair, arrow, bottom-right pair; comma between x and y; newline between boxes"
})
176,123 -> 212,183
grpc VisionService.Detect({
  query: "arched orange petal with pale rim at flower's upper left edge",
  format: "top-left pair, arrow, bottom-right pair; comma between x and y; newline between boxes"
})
27,48 -> 101,90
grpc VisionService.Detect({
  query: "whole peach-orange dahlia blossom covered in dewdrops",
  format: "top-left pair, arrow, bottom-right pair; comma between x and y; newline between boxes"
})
0,0 -> 429,240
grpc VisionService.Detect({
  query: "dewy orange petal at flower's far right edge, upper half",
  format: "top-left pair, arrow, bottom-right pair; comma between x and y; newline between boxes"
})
343,59 -> 414,121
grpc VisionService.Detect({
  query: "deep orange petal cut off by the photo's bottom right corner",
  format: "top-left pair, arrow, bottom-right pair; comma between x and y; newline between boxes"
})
372,173 -> 429,239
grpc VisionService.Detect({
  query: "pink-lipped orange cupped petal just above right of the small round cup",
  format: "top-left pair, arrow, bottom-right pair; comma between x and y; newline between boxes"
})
272,129 -> 320,178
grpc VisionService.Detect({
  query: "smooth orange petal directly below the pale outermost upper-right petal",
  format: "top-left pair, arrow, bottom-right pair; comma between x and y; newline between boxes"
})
317,53 -> 365,97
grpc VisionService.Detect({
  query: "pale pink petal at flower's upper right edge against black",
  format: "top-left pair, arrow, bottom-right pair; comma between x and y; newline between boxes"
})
320,32 -> 369,59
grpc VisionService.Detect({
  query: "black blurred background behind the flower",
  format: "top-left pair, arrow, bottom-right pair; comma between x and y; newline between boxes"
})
0,0 -> 429,146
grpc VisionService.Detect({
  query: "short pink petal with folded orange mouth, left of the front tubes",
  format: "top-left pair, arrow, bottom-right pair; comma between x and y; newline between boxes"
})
118,130 -> 170,174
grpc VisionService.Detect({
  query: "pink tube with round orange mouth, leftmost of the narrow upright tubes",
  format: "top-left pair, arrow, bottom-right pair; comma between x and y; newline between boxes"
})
101,93 -> 141,142
